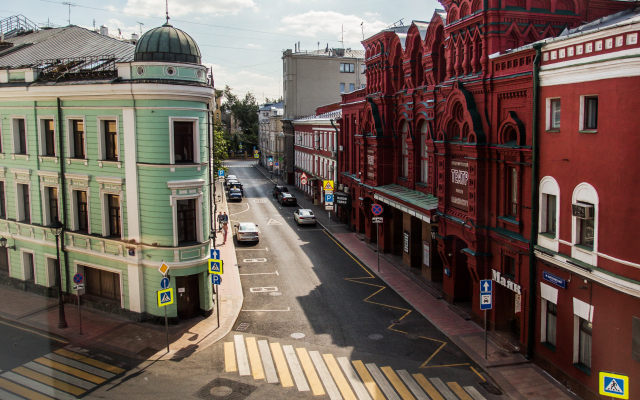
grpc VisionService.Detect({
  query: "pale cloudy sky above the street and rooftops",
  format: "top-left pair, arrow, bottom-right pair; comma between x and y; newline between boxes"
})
0,0 -> 442,103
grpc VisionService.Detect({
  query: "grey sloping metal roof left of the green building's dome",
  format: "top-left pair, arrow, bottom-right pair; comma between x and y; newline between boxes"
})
0,25 -> 135,68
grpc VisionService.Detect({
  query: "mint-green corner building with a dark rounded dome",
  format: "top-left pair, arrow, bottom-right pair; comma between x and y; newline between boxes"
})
0,23 -> 214,320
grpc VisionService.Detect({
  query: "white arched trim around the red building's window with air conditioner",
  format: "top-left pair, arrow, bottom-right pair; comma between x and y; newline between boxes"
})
571,182 -> 600,266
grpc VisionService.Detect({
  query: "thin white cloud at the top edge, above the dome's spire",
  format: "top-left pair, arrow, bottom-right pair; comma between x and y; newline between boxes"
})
124,0 -> 258,17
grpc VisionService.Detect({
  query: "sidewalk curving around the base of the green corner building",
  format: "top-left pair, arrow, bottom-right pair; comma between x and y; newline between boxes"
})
0,179 -> 243,360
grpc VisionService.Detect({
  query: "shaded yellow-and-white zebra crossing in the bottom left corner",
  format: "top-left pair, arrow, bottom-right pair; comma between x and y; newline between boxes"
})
0,349 -> 125,400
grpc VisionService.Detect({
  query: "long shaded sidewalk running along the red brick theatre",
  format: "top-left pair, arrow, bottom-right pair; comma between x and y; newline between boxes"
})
256,166 -> 579,400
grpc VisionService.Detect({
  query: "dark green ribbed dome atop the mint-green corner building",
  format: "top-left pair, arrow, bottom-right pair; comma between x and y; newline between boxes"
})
134,22 -> 201,64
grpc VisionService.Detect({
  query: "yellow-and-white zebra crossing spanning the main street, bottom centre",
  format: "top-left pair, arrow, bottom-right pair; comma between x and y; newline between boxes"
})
224,335 -> 486,400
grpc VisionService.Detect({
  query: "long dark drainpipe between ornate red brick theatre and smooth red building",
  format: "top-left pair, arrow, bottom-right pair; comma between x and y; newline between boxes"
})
525,43 -> 542,360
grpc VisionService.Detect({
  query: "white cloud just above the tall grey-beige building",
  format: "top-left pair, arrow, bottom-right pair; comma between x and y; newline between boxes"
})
278,11 -> 388,48
